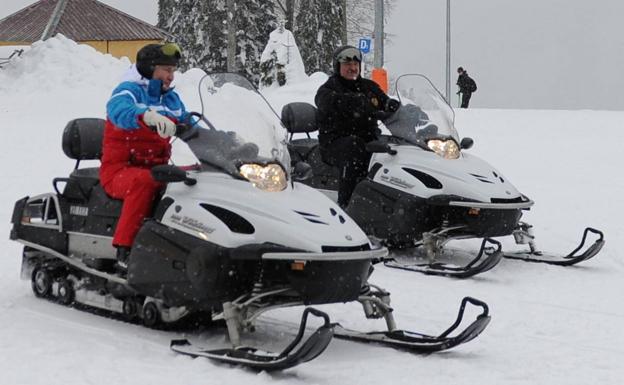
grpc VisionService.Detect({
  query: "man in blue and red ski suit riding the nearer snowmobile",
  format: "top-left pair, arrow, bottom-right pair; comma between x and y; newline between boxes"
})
100,43 -> 188,272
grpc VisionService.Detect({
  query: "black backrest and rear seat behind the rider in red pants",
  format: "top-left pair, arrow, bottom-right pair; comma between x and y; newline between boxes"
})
53,118 -> 105,200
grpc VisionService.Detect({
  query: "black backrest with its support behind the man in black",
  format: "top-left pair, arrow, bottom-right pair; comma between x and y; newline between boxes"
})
282,102 -> 318,162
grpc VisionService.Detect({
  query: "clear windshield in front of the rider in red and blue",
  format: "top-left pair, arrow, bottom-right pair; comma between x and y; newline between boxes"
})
178,73 -> 290,180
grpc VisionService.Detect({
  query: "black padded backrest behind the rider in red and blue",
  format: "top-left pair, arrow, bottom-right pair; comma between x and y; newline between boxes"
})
63,118 -> 106,161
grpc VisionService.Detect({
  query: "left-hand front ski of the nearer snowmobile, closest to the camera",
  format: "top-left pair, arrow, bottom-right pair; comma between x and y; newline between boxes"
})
171,308 -> 335,371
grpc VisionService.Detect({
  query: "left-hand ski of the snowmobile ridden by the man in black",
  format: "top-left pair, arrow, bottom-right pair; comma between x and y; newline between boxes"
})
384,238 -> 503,278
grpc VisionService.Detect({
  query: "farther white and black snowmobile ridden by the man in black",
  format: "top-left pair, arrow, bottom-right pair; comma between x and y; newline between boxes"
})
282,74 -> 604,278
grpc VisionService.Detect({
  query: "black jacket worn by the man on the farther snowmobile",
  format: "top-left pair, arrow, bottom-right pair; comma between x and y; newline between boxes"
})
314,75 -> 389,146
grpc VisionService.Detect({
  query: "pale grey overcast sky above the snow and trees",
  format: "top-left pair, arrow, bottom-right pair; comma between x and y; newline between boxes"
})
0,0 -> 624,110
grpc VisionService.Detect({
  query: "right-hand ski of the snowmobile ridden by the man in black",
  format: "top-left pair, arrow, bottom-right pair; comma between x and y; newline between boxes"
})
504,225 -> 605,266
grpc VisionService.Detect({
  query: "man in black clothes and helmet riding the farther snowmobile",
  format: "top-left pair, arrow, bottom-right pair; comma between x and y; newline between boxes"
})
314,46 -> 400,207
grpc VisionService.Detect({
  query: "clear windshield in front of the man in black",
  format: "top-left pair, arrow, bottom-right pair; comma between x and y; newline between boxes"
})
384,74 -> 459,148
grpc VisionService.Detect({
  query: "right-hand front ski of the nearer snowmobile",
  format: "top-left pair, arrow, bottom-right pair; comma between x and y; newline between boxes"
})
334,297 -> 491,353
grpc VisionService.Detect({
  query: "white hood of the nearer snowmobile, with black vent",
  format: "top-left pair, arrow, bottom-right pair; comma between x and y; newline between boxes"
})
162,172 -> 369,253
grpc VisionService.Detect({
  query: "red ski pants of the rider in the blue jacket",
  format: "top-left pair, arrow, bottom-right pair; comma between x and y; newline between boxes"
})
104,167 -> 164,247
